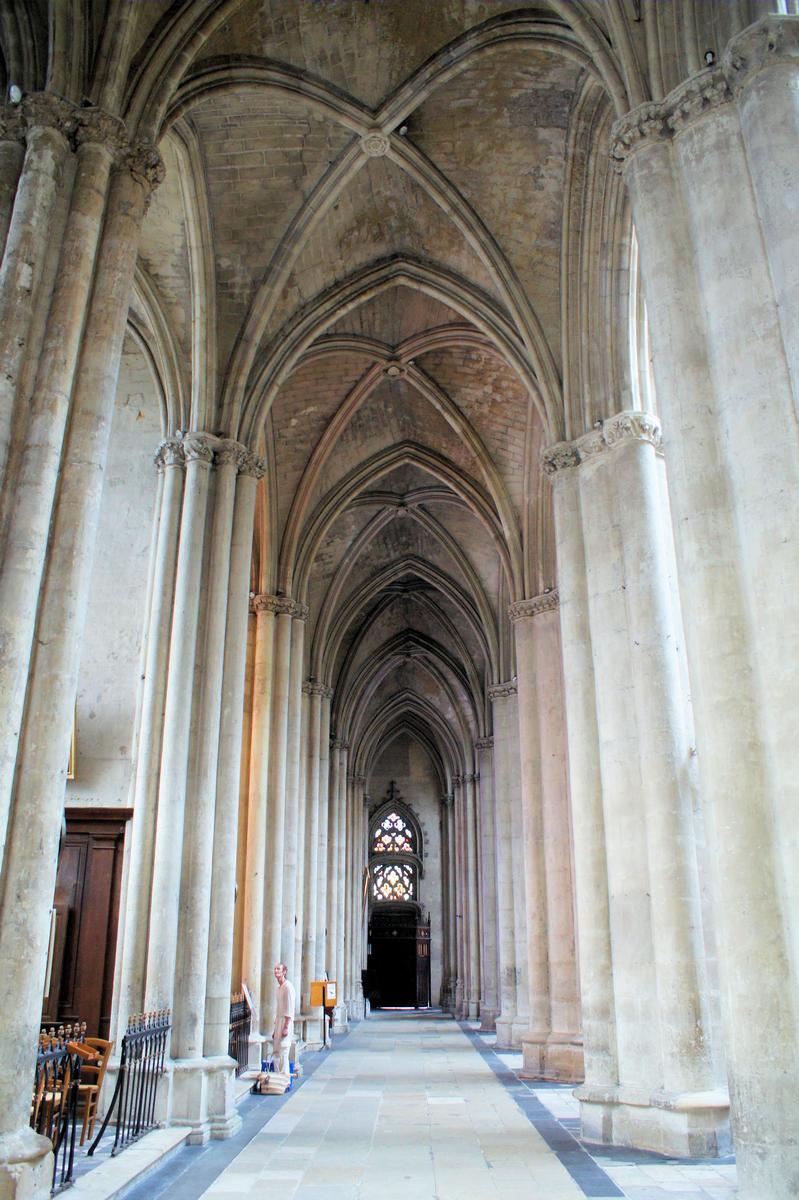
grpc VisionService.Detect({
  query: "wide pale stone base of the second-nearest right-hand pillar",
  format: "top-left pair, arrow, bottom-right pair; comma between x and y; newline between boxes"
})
575,1085 -> 732,1158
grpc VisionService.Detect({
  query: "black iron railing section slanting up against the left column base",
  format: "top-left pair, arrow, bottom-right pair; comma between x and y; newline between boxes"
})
89,1008 -> 172,1158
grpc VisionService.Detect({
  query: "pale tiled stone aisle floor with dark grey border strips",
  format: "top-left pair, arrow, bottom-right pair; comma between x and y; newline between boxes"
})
121,1013 -> 735,1200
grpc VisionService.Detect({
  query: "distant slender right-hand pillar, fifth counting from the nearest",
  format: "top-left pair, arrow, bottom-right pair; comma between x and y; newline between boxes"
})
474,738 -> 499,1031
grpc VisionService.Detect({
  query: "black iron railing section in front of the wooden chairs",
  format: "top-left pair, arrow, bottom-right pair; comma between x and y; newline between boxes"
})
30,1022 -> 86,1193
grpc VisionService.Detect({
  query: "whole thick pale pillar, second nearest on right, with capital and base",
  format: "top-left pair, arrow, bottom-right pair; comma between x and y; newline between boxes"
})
542,413 -> 727,1154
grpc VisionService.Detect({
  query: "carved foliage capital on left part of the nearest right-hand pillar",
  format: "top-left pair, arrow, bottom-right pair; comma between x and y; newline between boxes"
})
611,66 -> 732,164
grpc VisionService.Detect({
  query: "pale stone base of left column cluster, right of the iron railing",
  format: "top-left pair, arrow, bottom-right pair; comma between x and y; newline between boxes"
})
169,1055 -> 241,1146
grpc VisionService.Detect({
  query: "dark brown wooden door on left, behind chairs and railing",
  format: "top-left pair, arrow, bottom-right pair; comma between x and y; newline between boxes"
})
42,809 -> 131,1038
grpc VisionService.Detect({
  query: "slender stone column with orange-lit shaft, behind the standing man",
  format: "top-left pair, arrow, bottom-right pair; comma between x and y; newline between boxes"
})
241,593 -> 281,1032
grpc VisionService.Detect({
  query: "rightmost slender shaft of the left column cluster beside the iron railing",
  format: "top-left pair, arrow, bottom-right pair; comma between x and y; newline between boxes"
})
203,452 -> 265,1138
